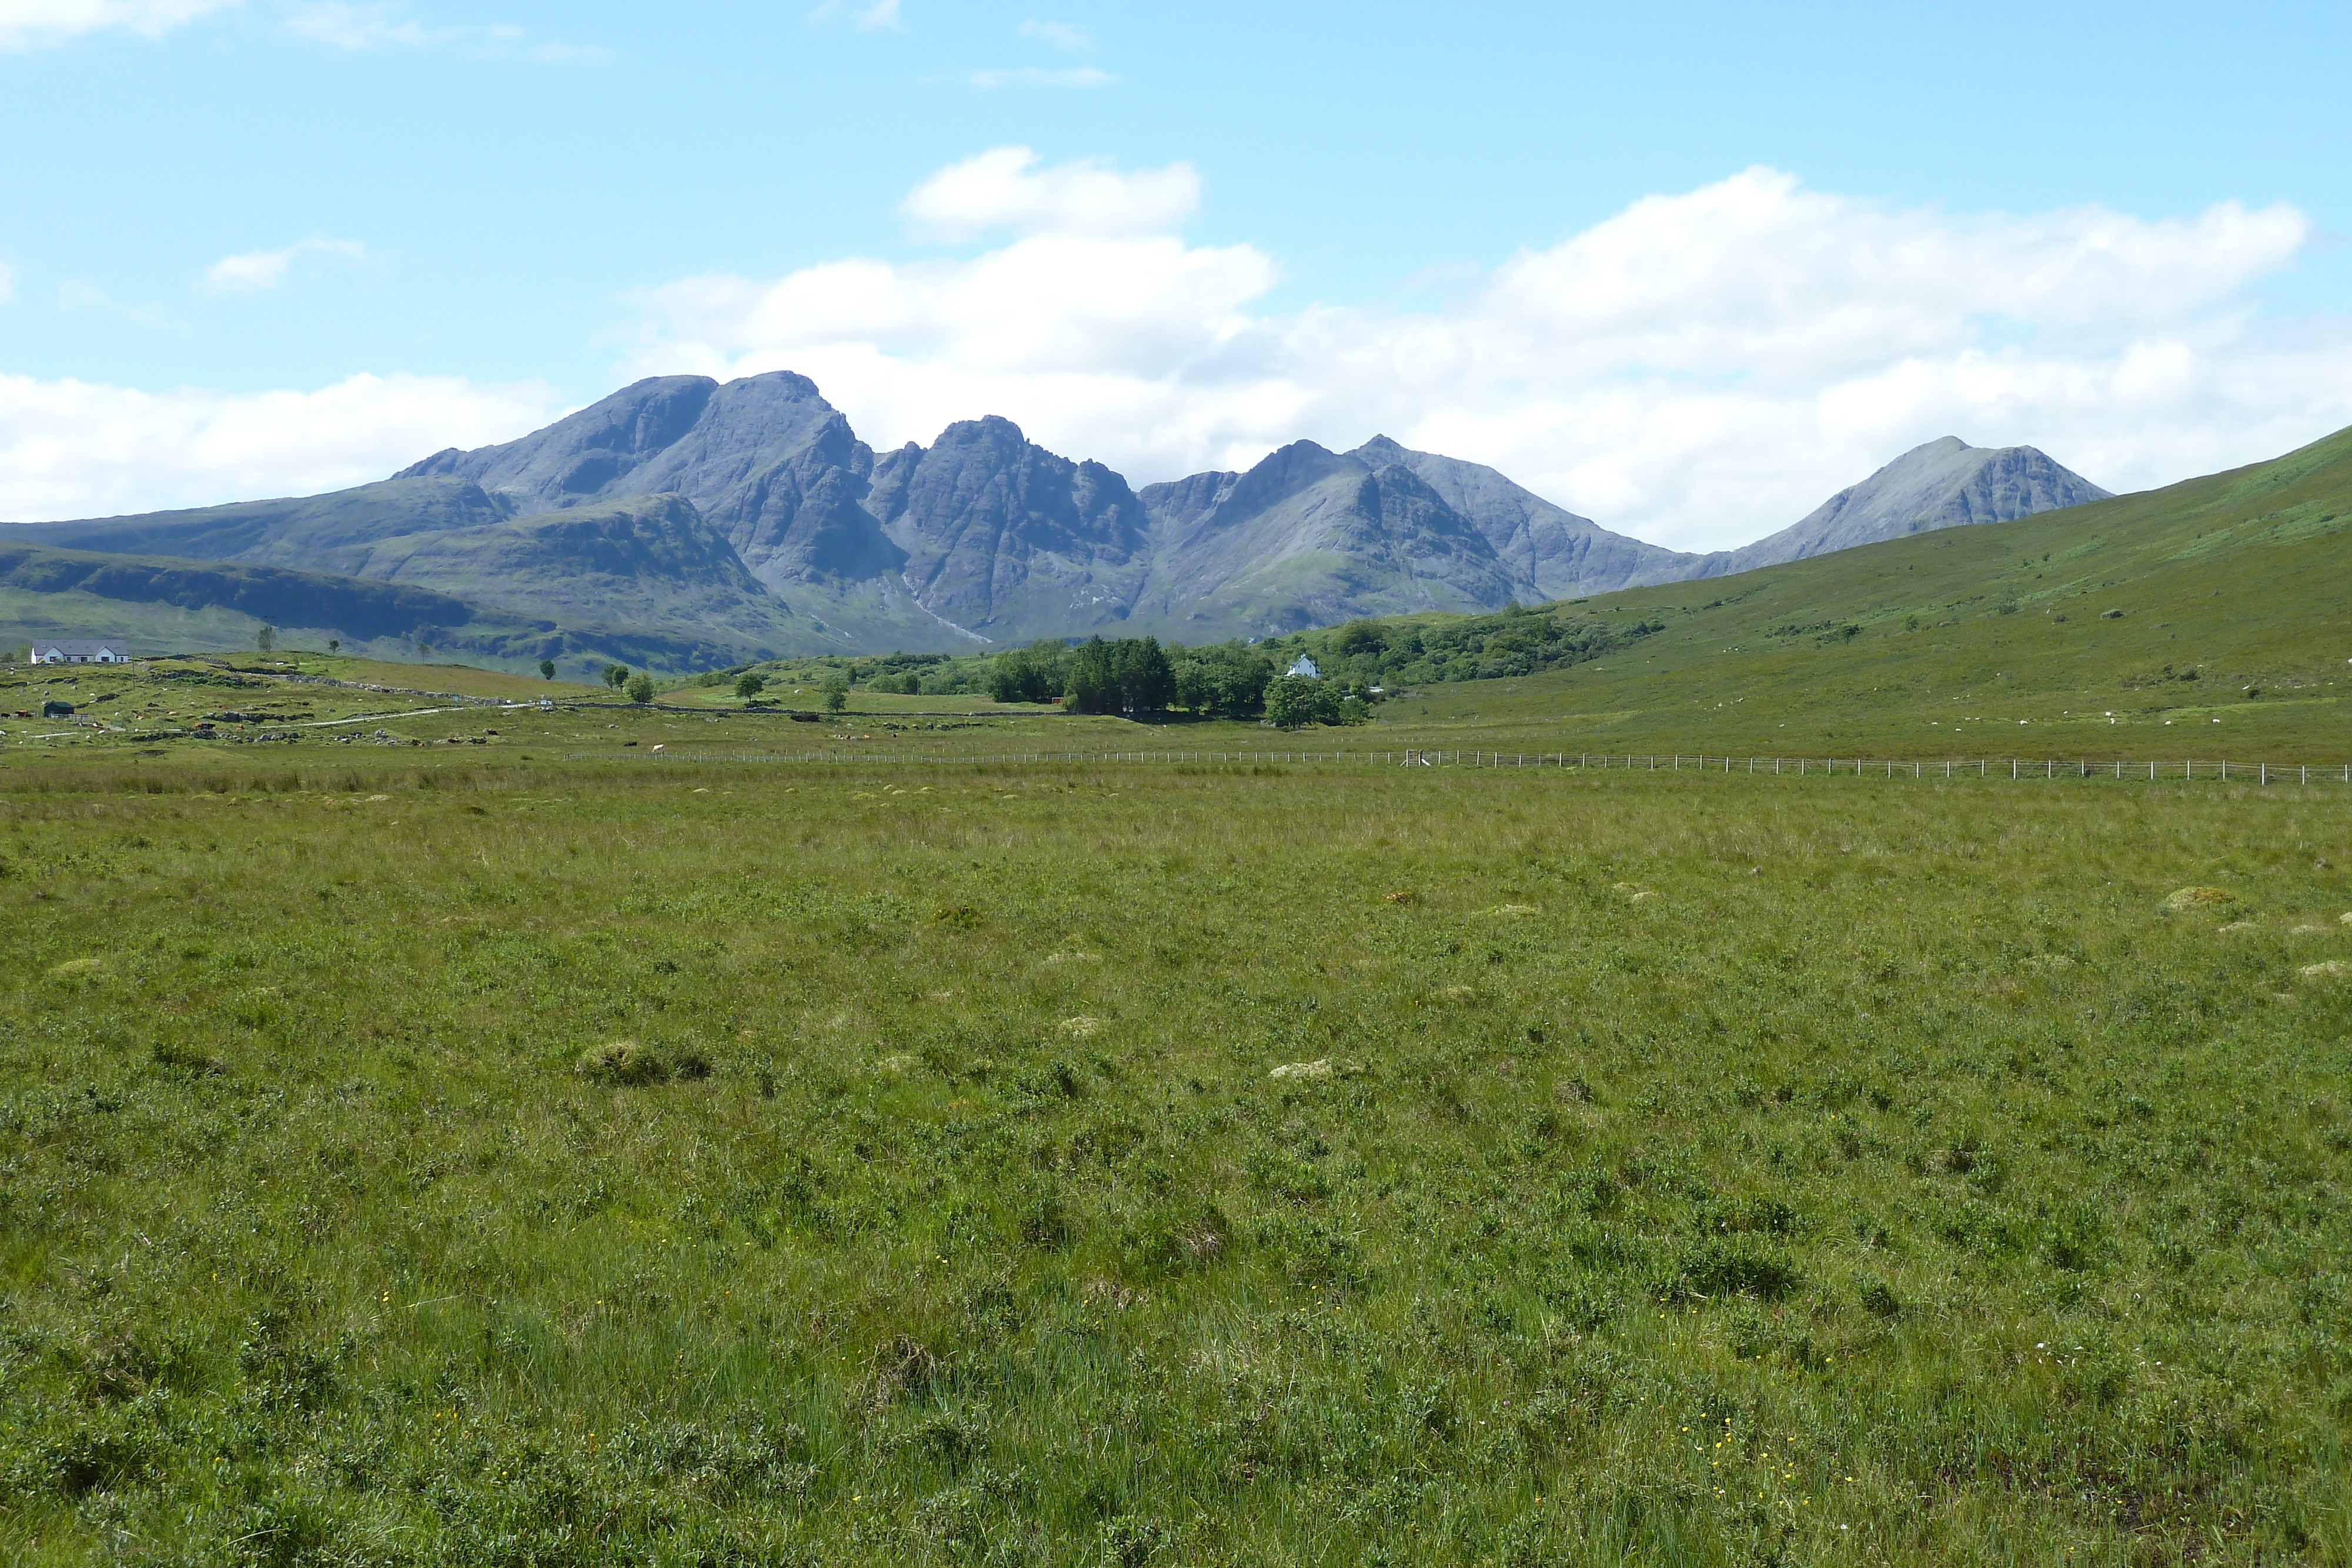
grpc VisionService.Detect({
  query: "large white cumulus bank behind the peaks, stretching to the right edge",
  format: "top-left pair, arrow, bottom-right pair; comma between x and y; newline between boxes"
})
635,161 -> 2352,548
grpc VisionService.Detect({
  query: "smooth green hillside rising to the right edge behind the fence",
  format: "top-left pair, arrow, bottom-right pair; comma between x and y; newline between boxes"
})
1265,416 -> 2352,760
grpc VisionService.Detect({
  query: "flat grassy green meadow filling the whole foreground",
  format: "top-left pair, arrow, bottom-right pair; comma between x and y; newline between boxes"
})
0,752 -> 2352,1566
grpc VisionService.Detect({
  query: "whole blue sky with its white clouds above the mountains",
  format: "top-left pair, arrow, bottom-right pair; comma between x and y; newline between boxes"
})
0,0 -> 2352,543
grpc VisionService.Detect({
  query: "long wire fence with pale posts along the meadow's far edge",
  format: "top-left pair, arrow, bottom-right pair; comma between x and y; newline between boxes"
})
564,748 -> 2352,785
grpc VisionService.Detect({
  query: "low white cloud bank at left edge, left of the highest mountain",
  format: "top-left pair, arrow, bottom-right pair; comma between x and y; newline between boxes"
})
0,374 -> 562,522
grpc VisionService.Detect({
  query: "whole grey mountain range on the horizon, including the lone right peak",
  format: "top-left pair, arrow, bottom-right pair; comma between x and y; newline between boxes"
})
0,372 -> 2107,668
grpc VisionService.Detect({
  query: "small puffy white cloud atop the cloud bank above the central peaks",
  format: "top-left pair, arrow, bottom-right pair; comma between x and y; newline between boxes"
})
898,148 -> 1200,240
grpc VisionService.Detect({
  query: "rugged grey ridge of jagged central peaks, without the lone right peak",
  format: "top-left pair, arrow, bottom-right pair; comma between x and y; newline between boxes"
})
400,372 -> 1731,647
